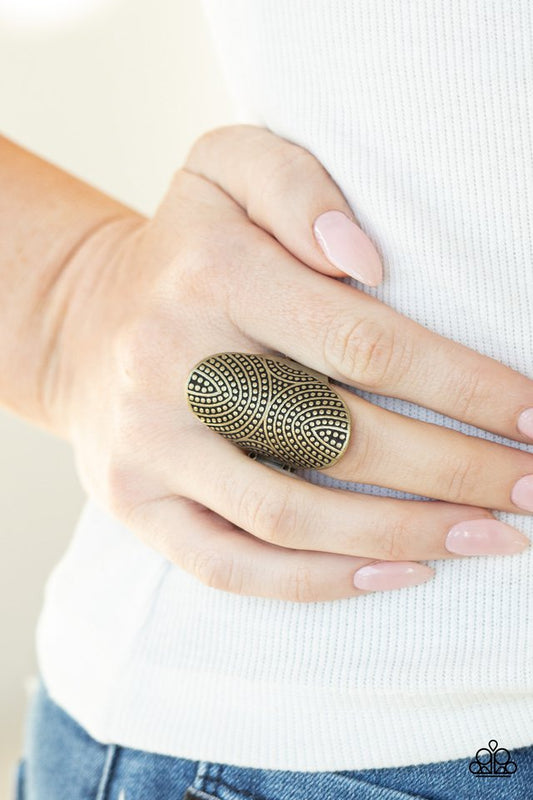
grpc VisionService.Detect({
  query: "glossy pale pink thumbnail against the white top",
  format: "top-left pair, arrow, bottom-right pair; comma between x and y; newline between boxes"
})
313,211 -> 383,286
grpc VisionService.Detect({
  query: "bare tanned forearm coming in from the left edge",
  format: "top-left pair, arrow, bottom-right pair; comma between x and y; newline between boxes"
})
0,137 -> 142,429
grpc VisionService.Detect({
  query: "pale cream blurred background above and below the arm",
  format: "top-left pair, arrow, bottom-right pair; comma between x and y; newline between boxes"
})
0,0 -> 236,800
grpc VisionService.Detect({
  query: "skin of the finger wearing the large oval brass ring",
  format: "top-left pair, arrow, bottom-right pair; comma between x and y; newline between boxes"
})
124,266 -> 533,513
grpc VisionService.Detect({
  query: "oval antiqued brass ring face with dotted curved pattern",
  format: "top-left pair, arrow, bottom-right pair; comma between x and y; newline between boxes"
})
187,353 -> 351,469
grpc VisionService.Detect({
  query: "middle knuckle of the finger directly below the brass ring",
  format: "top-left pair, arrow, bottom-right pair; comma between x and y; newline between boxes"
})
239,485 -> 300,546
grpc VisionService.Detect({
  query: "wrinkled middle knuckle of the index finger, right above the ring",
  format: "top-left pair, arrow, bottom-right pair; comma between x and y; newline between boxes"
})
324,319 -> 406,389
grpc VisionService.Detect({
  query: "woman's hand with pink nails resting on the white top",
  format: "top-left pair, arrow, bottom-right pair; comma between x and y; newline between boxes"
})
45,126 -> 533,602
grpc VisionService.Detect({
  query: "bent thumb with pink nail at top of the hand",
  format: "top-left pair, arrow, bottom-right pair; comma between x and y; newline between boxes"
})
185,125 -> 383,286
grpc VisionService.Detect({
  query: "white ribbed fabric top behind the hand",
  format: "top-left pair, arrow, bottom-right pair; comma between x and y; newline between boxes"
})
38,0 -> 533,771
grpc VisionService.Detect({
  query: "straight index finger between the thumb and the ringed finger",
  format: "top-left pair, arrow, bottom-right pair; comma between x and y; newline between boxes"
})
224,234 -> 533,442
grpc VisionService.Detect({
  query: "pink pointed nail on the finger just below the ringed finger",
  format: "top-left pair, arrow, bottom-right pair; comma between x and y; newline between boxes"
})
446,519 -> 529,556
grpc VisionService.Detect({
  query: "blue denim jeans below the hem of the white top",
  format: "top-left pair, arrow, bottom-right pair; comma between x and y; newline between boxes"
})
15,683 -> 533,800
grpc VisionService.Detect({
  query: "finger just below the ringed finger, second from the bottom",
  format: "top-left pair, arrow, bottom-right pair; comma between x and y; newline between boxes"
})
167,423 -> 528,561
